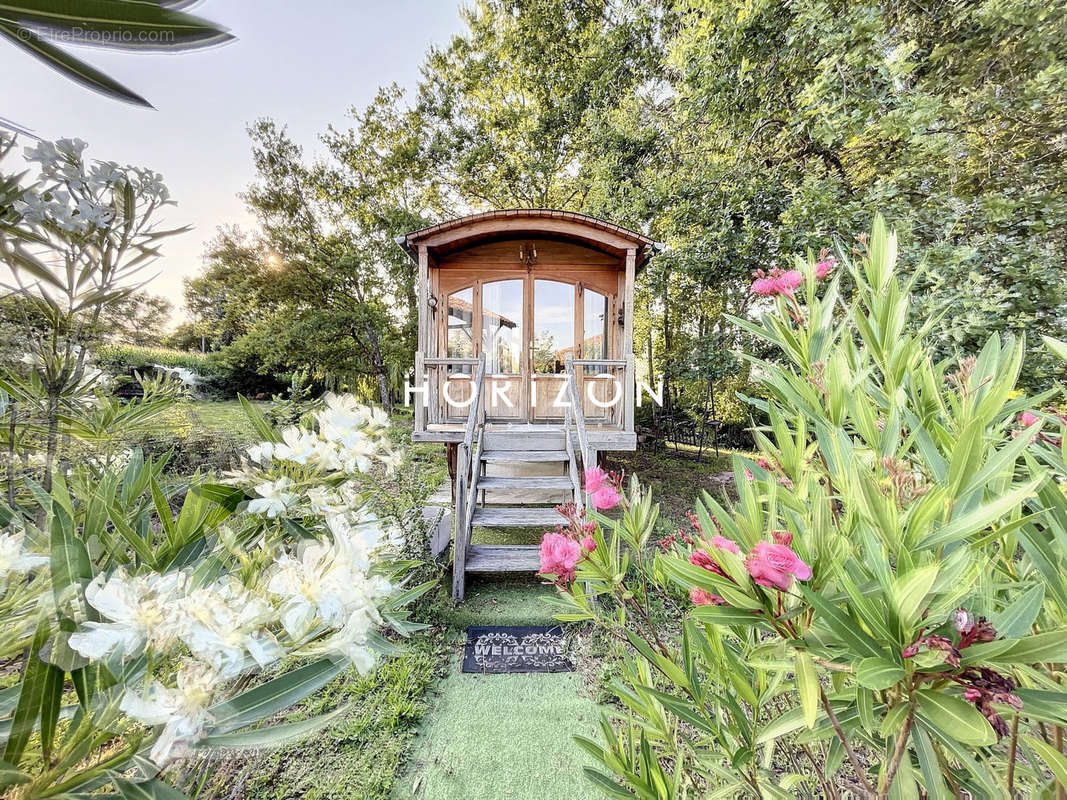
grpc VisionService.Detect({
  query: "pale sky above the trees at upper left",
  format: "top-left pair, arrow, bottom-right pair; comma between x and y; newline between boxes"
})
0,0 -> 462,323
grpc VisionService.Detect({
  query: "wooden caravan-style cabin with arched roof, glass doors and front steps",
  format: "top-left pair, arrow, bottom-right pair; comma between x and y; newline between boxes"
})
397,209 -> 655,598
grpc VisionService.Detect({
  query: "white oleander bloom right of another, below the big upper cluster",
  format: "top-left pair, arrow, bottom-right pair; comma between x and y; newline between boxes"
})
178,577 -> 285,679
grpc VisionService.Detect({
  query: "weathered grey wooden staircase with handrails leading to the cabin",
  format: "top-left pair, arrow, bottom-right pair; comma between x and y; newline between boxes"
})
452,358 -> 589,601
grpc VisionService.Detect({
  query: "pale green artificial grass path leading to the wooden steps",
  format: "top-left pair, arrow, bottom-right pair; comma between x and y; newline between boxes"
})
393,576 -> 602,800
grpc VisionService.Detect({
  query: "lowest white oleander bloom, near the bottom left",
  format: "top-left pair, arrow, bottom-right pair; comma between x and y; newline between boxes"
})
118,661 -> 220,766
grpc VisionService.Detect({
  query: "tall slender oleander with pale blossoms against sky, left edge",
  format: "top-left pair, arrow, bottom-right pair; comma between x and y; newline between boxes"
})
0,133 -> 187,491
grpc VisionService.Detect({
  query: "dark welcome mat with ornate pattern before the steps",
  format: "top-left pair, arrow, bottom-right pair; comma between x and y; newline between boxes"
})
463,625 -> 574,672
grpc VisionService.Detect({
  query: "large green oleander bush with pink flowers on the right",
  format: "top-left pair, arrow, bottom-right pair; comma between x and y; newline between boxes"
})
542,219 -> 1067,798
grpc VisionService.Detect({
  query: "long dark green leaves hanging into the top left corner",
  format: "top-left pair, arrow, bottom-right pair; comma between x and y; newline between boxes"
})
0,0 -> 233,108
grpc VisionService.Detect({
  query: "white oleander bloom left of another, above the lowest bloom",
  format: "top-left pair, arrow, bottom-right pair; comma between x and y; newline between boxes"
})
69,569 -> 186,660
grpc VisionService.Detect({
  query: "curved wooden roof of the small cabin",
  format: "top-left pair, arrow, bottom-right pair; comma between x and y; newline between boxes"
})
397,208 -> 657,266
